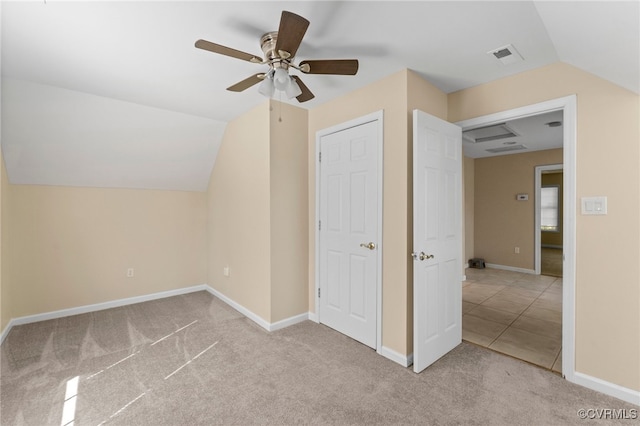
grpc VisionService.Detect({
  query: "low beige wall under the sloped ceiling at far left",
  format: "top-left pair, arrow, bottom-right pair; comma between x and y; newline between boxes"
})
5,185 -> 207,318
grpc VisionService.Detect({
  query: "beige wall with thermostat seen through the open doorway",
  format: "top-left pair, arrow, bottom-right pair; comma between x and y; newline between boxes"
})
473,149 -> 562,270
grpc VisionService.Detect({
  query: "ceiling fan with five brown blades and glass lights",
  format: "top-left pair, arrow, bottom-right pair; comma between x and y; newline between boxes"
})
196,10 -> 358,102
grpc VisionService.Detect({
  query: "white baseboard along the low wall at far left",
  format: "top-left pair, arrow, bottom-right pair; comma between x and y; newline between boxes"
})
0,284 -> 209,344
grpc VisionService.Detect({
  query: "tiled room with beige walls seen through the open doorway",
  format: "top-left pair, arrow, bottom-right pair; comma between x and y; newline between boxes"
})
462,105 -> 564,374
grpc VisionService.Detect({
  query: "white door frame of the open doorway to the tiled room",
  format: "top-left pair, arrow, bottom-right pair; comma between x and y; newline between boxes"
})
456,95 -> 577,382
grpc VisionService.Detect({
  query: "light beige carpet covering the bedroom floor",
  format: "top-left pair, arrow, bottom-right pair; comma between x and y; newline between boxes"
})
0,292 -> 636,426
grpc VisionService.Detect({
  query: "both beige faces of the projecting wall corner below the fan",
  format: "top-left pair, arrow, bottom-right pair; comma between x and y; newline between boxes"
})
208,101 -> 308,323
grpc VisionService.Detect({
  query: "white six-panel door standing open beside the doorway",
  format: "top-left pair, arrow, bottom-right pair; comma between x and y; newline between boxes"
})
412,110 -> 462,373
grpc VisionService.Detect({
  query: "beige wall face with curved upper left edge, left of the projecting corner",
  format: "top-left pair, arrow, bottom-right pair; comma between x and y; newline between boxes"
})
207,102 -> 271,321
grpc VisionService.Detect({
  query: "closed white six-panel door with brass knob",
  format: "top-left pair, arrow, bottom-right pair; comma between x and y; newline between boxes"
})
318,121 -> 380,348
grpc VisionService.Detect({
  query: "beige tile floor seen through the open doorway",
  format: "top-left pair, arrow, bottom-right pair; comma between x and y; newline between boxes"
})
462,268 -> 562,373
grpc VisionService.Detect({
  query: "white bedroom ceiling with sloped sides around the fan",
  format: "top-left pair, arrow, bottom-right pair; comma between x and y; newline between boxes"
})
0,0 -> 640,190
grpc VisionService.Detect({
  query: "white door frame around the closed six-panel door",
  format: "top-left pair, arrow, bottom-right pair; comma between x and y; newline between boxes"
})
314,110 -> 384,353
